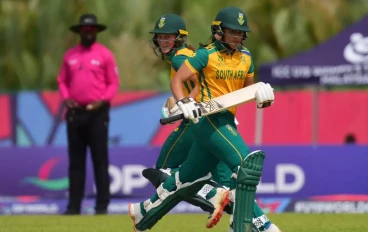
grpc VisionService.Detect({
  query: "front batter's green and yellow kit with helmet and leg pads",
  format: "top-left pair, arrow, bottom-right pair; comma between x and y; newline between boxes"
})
135,7 -> 269,231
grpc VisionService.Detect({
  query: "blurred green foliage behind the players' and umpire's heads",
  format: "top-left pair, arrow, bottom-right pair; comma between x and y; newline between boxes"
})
0,0 -> 368,90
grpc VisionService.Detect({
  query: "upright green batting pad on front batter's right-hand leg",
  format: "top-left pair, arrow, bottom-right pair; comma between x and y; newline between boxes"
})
233,151 -> 265,232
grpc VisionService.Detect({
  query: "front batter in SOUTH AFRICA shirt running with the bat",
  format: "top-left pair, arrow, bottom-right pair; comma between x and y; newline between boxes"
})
129,7 -> 280,232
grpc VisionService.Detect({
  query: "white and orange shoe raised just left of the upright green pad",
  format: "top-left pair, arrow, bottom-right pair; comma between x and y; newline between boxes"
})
206,188 -> 230,228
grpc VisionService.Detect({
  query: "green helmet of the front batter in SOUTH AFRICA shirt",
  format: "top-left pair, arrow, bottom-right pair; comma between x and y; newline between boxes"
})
212,6 -> 250,32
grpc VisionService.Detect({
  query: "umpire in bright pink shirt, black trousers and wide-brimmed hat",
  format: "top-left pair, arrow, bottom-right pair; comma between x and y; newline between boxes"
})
58,14 -> 119,215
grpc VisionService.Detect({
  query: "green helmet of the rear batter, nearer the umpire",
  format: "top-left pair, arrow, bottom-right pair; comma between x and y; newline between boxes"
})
150,14 -> 188,35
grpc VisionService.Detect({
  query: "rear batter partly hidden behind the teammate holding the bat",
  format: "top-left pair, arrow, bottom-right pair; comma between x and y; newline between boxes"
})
143,14 -> 229,227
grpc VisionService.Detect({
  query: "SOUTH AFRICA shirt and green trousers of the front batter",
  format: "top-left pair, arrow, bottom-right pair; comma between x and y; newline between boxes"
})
179,41 -> 254,182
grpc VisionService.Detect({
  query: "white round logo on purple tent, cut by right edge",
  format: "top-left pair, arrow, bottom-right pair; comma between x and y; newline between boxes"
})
344,33 -> 368,64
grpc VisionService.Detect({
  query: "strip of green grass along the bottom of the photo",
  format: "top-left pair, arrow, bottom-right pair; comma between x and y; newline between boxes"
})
0,214 -> 368,232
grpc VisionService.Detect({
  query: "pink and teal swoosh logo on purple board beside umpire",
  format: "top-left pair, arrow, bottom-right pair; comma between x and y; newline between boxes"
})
22,158 -> 69,191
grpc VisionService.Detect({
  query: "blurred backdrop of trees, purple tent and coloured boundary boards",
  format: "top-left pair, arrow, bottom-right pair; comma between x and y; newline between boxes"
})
0,0 -> 368,218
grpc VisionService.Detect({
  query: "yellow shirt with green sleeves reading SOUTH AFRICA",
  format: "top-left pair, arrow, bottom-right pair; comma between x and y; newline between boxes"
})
190,41 -> 254,115
